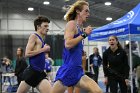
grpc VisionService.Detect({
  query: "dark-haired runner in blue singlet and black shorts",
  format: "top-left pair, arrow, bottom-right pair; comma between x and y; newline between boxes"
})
17,16 -> 51,93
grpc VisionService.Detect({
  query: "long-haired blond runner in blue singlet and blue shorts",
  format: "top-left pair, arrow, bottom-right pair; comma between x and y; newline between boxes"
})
51,1 -> 102,93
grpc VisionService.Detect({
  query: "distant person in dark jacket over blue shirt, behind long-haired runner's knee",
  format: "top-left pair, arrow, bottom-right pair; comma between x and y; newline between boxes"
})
89,47 -> 102,83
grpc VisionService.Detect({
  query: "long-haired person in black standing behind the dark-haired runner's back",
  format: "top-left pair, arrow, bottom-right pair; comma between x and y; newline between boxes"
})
15,47 -> 28,86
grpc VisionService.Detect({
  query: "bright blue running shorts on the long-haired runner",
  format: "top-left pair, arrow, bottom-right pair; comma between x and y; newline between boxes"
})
55,66 -> 84,87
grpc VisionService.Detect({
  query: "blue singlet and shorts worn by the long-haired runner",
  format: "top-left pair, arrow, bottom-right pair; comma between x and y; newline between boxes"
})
55,26 -> 84,86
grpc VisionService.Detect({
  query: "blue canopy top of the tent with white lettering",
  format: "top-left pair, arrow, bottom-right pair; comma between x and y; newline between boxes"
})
88,4 -> 140,41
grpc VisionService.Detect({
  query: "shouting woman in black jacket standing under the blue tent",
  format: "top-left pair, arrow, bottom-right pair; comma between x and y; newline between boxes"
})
103,36 -> 130,93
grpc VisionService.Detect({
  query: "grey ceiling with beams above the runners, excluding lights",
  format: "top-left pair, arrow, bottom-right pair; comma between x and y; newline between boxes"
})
0,0 -> 140,26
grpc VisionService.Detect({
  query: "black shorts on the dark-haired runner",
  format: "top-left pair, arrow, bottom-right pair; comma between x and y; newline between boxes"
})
23,66 -> 46,87
